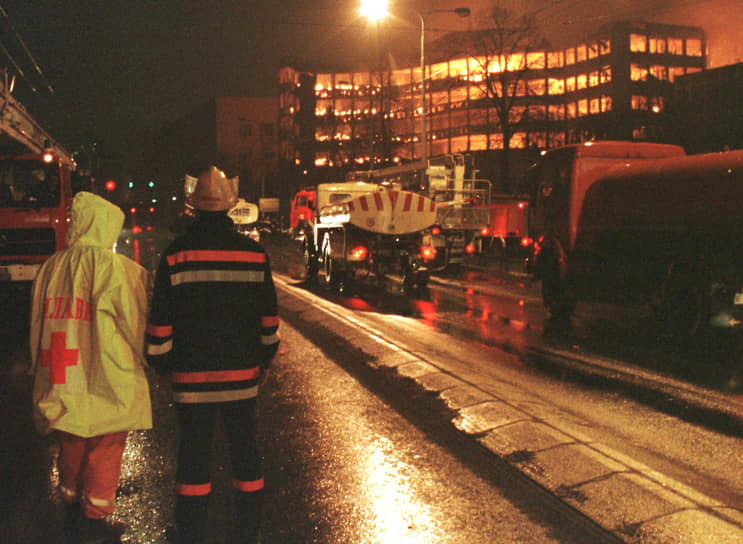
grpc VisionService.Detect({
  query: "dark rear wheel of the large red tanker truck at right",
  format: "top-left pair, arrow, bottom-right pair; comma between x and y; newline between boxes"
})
661,270 -> 710,340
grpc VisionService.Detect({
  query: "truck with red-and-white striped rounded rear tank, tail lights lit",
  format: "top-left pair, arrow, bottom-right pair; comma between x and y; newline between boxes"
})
303,182 -> 436,291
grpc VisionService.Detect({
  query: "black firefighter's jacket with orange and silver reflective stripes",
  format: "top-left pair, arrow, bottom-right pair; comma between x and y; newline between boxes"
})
147,213 -> 279,403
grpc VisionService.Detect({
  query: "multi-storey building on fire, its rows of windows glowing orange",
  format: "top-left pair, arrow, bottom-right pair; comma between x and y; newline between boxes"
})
279,22 -> 707,189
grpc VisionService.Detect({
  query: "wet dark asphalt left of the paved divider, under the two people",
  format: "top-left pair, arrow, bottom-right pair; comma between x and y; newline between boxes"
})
0,316 -> 616,544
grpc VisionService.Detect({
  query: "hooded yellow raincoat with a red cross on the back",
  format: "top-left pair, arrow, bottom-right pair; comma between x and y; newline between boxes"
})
30,192 -> 152,438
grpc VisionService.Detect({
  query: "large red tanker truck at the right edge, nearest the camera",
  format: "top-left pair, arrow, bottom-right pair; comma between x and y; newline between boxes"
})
527,142 -> 743,338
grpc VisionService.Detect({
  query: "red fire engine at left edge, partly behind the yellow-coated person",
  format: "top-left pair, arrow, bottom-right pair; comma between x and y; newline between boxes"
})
0,77 -> 77,295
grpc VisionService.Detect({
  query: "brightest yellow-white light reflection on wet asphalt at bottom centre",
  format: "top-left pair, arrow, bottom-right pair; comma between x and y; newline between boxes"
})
365,437 -> 438,544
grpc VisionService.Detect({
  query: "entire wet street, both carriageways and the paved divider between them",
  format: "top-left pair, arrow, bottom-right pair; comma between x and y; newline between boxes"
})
0,232 -> 743,544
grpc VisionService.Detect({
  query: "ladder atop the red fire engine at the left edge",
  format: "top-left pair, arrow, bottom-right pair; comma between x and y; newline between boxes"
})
0,70 -> 74,164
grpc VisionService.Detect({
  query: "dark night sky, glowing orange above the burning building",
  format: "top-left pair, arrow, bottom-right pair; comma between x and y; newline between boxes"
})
0,0 -> 743,177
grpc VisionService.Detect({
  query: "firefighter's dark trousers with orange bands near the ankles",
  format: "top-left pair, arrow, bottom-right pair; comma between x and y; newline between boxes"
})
175,399 -> 263,544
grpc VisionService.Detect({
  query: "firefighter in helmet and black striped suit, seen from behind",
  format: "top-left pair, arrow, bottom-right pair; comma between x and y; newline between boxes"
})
147,167 -> 279,543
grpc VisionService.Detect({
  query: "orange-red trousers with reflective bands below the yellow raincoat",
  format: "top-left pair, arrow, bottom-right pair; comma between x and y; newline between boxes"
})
57,431 -> 128,519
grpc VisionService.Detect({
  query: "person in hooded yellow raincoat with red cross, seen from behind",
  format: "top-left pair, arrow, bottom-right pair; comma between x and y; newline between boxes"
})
30,192 -> 152,542
